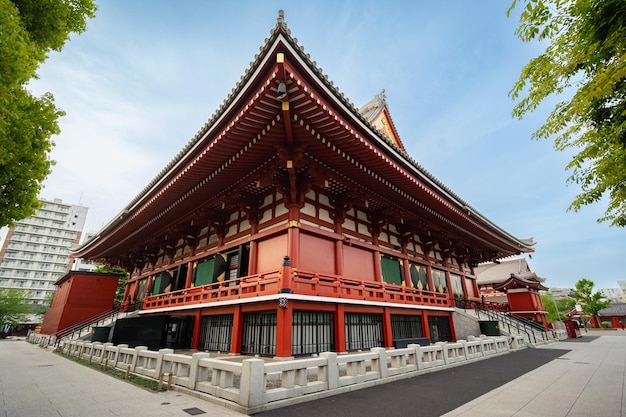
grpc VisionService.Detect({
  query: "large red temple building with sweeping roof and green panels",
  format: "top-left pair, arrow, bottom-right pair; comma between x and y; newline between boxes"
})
74,12 -> 534,357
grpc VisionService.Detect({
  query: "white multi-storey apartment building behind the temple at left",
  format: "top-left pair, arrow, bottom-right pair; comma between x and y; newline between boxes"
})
0,199 -> 88,305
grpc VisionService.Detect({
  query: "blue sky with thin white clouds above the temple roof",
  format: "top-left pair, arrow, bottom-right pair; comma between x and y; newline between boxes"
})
30,0 -> 626,288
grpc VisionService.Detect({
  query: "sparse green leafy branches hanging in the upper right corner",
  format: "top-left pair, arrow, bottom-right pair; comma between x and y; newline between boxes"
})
509,0 -> 626,227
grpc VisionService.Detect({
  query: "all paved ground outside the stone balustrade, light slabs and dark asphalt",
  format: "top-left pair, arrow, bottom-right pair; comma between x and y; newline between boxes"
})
0,330 -> 626,417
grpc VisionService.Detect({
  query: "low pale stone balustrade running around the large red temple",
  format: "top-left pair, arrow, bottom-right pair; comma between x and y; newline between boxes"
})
47,336 -> 526,414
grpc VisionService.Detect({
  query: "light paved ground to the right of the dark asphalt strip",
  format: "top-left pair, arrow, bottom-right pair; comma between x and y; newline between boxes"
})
445,330 -> 626,417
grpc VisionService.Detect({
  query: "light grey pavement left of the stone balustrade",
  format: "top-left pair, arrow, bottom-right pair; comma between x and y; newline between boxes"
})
0,340 -> 245,417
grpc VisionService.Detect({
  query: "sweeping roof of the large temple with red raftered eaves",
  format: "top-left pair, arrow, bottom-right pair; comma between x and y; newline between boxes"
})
74,12 -> 534,259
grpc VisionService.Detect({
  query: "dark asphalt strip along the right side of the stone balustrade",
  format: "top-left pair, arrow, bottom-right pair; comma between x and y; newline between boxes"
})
254,349 -> 569,417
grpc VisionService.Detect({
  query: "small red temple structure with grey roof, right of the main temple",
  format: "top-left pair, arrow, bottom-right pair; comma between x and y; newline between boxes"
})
474,258 -> 548,328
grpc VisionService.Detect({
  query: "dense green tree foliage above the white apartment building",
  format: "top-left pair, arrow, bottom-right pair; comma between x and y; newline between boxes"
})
0,0 -> 96,227
